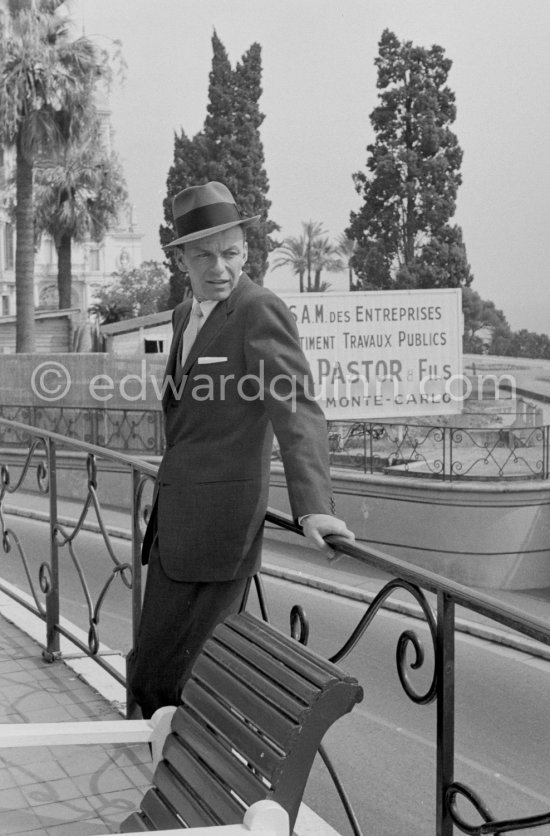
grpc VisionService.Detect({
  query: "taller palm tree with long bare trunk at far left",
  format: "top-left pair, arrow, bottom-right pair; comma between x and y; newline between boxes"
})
0,0 -> 109,352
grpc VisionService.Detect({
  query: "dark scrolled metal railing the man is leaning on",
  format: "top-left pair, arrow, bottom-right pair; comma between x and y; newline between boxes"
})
0,419 -> 550,836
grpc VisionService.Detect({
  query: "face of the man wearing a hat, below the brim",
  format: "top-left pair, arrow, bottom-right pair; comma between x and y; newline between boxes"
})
175,226 -> 248,302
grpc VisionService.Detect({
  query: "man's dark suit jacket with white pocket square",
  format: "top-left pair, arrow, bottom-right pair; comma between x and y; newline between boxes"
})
143,274 -> 334,581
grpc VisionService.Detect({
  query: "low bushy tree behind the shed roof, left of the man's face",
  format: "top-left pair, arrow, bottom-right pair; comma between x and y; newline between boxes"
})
90,261 -> 170,325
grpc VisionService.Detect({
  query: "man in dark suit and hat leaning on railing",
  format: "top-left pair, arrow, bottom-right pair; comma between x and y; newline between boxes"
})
128,182 -> 353,717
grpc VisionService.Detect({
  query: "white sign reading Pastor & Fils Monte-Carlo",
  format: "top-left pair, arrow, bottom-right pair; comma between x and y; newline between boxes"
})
282,288 -> 463,420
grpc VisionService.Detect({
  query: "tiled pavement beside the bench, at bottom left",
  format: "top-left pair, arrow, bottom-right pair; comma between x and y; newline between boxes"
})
0,615 -> 152,836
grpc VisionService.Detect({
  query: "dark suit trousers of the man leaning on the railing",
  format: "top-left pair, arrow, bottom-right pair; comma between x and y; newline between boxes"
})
126,537 -> 249,719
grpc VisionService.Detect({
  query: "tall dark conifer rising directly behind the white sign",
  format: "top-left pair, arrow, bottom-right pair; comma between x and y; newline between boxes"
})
347,29 -> 472,289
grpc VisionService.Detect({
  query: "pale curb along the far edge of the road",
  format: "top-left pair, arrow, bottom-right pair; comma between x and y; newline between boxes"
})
5,505 -> 550,664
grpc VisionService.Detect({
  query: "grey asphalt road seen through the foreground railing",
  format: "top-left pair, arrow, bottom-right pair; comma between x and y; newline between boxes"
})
0,518 -> 550,836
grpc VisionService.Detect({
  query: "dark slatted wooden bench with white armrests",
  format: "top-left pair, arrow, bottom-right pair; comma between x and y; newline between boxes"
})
0,613 -> 363,833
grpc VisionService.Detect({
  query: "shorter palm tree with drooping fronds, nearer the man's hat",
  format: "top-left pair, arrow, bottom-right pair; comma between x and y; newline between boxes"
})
35,116 -> 127,308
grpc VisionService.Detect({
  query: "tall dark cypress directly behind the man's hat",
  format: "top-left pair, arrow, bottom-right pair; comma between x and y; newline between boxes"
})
160,32 -> 279,304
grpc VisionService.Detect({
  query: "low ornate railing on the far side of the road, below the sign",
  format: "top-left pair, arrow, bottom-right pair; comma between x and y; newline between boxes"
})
0,406 -> 550,481
